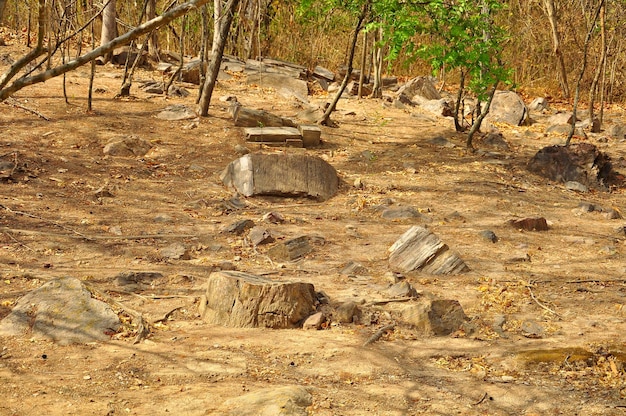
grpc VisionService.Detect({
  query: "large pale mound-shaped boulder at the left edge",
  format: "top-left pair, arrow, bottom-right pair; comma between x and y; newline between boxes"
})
0,277 -> 120,345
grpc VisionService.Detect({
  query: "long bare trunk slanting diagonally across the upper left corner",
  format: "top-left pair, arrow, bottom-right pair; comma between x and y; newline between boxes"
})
0,0 -> 209,102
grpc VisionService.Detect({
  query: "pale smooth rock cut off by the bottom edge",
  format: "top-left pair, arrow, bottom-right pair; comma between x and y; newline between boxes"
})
218,386 -> 313,416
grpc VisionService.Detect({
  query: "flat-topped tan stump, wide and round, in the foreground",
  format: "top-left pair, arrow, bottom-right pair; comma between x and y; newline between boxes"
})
200,271 -> 316,329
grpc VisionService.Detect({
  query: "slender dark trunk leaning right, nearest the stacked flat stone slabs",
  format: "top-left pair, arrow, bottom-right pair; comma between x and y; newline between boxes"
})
198,0 -> 239,117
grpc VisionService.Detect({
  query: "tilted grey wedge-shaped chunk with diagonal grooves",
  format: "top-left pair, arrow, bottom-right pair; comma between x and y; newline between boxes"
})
389,226 -> 469,274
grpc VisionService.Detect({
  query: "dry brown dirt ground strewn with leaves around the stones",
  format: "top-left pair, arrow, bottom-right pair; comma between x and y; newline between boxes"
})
0,39 -> 626,415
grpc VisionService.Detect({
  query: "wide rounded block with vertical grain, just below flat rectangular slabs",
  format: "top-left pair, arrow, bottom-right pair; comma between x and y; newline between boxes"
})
221,153 -> 339,201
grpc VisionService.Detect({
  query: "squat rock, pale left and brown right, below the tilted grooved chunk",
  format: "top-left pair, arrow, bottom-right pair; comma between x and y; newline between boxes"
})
401,297 -> 468,336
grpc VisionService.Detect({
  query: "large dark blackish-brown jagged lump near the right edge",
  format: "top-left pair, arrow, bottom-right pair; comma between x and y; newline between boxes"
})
527,143 -> 623,190
